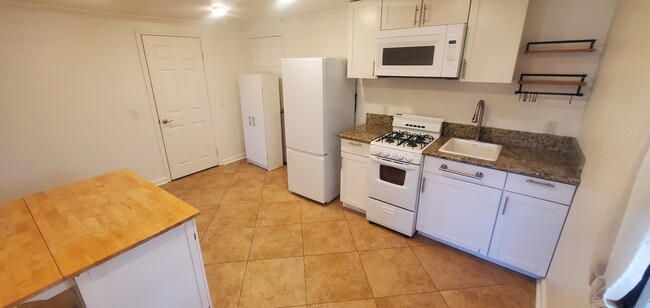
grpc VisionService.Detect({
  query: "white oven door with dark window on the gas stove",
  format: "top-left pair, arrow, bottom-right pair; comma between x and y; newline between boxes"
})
368,156 -> 421,211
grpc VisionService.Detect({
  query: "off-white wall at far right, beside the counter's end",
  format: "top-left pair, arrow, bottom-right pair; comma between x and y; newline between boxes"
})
545,0 -> 650,307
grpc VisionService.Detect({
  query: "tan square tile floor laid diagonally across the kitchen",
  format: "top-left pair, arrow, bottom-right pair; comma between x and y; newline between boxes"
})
162,161 -> 535,308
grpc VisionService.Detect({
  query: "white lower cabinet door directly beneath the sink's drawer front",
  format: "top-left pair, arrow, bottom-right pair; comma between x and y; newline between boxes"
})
417,172 -> 501,255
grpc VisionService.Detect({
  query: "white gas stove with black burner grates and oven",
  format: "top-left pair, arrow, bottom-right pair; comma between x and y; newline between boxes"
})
366,114 -> 444,236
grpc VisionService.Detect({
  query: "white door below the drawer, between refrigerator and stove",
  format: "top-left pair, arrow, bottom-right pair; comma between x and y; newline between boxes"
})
341,152 -> 368,211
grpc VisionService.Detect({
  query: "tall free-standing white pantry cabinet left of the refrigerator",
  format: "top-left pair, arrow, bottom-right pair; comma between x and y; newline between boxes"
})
239,74 -> 283,170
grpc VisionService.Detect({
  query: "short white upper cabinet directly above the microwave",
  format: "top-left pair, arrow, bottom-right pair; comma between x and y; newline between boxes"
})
381,0 -> 470,30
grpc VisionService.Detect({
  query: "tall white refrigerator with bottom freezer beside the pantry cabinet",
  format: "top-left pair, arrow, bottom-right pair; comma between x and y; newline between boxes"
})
282,58 -> 355,203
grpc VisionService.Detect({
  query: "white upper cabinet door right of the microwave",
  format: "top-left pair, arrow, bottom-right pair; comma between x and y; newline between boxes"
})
461,0 -> 528,83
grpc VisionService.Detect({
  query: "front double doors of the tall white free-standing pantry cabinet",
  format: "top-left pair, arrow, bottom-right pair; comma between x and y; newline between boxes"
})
239,75 -> 267,166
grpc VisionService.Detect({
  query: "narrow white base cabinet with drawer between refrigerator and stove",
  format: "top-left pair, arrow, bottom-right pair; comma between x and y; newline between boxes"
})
341,139 -> 370,212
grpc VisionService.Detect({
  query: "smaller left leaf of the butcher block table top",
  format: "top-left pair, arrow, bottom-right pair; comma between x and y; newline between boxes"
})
0,200 -> 63,307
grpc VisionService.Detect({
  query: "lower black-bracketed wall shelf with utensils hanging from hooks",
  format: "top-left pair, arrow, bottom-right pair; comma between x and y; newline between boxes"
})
515,74 -> 587,104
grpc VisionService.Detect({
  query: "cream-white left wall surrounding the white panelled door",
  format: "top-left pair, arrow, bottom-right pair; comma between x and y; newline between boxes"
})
0,4 -> 247,202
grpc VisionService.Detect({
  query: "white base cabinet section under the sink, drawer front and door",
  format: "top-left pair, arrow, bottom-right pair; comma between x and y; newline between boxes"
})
416,157 -> 506,255
